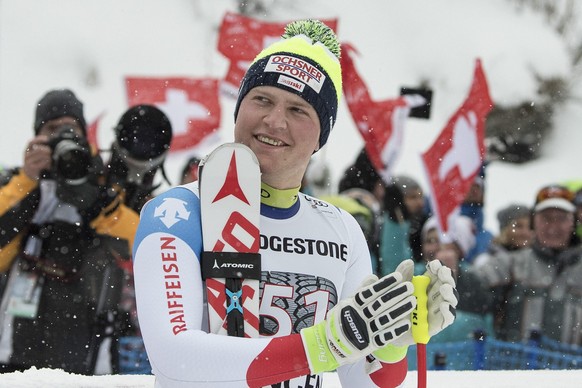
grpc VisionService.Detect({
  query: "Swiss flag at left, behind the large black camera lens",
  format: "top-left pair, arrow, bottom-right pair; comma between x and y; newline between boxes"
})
125,77 -> 221,152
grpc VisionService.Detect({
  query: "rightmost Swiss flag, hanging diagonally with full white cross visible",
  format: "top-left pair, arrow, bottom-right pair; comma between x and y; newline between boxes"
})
422,59 -> 493,233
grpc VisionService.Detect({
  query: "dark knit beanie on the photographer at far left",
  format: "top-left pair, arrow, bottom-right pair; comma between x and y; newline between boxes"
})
34,89 -> 87,134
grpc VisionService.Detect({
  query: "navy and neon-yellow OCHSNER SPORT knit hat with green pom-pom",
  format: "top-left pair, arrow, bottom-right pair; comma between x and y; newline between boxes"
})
234,20 -> 342,148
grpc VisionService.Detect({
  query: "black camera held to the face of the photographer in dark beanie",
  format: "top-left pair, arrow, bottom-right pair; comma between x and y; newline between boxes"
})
48,125 -> 92,186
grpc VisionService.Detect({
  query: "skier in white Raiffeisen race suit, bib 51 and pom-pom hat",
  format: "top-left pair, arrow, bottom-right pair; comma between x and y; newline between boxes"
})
134,20 -> 457,388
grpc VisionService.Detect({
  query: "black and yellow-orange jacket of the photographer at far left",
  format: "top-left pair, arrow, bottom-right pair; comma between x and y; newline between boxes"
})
0,165 -> 139,374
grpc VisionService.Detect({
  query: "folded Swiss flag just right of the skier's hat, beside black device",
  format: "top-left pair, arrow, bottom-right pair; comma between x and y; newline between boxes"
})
341,43 -> 425,183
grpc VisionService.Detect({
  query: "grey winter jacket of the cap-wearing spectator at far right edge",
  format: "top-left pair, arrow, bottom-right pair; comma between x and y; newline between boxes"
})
473,244 -> 582,345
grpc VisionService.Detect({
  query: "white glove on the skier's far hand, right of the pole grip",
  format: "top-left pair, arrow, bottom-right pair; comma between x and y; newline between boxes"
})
391,260 -> 459,346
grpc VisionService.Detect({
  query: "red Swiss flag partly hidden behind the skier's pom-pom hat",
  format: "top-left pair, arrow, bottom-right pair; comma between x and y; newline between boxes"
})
218,12 -> 337,95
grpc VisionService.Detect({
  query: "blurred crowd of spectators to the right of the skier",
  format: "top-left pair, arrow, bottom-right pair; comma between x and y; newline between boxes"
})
328,147 -> 582,346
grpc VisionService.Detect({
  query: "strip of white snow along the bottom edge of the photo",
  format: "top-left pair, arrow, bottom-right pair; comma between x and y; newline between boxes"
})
0,369 -> 582,388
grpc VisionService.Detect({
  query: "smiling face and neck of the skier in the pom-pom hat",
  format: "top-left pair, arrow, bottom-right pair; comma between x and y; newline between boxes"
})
234,86 -> 320,189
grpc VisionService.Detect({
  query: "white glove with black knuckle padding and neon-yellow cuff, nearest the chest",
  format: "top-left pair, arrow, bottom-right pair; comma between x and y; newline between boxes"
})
300,262 -> 416,373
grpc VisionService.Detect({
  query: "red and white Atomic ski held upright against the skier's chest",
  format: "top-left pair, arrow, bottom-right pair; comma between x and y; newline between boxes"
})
199,143 -> 261,338
